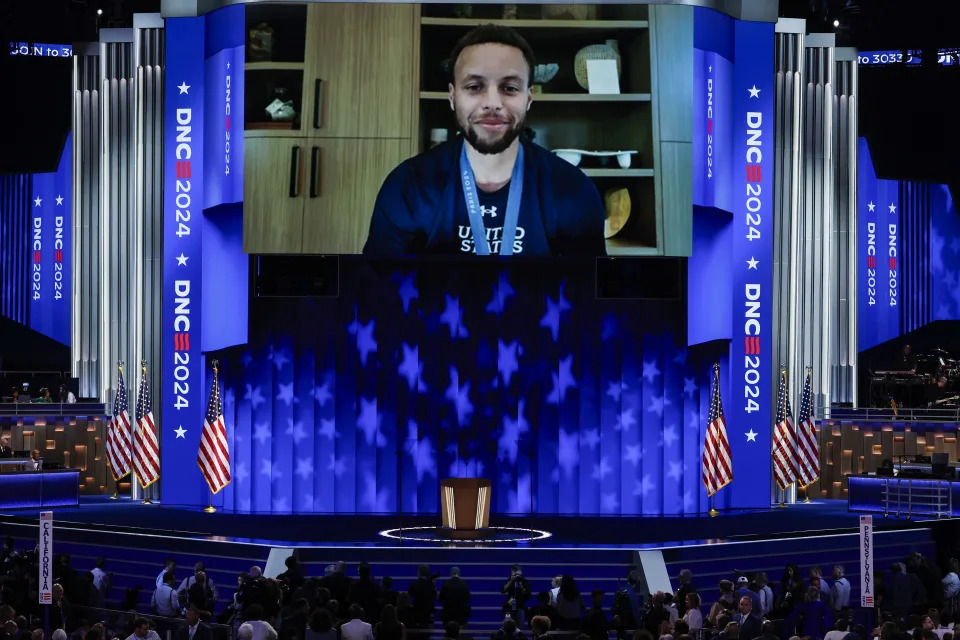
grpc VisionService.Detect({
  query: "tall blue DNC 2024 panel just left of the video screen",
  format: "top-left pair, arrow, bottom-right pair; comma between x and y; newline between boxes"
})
157,5 -> 248,504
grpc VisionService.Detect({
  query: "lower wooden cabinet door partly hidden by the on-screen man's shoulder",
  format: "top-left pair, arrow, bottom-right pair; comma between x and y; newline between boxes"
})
303,138 -> 408,253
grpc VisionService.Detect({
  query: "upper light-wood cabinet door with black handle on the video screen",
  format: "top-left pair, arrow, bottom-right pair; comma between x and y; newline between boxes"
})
306,2 -> 419,138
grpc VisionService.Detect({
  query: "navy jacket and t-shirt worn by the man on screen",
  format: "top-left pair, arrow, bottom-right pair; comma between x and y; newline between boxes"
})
363,138 -> 606,257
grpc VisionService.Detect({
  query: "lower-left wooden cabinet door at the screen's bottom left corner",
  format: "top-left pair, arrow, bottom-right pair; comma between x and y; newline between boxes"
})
243,138 -> 308,253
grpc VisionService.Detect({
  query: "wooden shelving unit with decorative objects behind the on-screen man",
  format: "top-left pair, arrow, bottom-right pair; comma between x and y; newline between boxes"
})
419,4 -> 663,256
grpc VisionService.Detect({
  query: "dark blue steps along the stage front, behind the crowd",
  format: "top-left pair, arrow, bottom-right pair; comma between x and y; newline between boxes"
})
3,523 -> 934,637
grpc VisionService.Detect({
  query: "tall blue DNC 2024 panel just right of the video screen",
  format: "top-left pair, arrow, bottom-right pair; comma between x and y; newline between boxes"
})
688,8 -> 772,508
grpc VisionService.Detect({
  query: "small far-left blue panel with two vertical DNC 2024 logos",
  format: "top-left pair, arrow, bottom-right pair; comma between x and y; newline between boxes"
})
29,135 -> 73,344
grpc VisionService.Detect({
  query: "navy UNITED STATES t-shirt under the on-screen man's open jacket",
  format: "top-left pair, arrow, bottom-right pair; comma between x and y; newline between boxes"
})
453,182 -> 550,255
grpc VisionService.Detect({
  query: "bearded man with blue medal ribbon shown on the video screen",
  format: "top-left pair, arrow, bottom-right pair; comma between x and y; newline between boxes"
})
363,24 -> 605,257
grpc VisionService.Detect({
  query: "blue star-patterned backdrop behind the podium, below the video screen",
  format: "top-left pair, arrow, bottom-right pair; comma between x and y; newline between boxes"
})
199,258 -> 732,515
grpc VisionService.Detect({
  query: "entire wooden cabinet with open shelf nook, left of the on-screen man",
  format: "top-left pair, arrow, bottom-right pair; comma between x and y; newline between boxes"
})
243,2 -> 419,253
